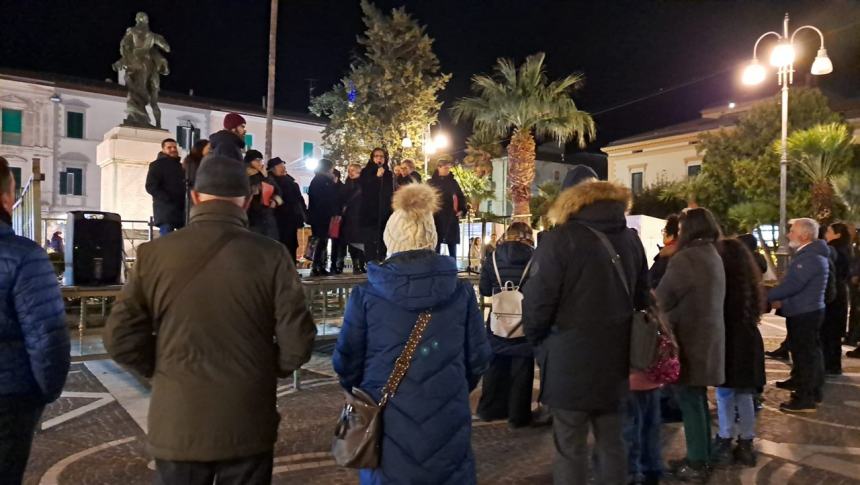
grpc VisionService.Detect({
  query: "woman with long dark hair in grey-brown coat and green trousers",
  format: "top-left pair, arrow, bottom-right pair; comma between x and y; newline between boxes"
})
656,208 -> 726,480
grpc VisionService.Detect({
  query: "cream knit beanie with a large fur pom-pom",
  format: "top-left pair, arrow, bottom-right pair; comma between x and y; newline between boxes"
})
382,184 -> 439,254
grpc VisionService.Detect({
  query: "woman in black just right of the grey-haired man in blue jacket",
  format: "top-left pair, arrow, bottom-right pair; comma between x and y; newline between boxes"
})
821,222 -> 853,375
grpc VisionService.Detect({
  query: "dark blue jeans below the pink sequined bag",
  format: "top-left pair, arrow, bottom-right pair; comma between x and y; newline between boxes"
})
624,389 -> 663,481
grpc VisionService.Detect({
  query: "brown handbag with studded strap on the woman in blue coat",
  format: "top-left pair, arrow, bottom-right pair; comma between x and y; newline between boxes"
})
331,312 -> 431,468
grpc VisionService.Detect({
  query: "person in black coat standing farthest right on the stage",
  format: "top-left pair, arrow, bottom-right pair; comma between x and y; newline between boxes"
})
428,160 -> 466,258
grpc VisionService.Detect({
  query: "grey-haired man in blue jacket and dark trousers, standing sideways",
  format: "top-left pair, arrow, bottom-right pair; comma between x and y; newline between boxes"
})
767,219 -> 829,413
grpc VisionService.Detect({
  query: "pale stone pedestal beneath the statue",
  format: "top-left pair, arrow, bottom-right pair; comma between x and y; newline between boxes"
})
96,126 -> 170,221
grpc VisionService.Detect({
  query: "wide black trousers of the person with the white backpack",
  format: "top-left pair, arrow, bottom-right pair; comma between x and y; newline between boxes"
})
478,354 -> 535,426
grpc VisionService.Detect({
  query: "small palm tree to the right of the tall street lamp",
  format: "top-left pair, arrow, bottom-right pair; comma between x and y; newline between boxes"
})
787,123 -> 853,224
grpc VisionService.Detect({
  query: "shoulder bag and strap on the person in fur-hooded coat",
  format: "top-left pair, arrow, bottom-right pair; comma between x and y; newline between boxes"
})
585,226 -> 672,372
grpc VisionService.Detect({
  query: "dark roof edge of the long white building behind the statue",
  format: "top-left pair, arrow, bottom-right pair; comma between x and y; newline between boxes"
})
0,69 -> 328,127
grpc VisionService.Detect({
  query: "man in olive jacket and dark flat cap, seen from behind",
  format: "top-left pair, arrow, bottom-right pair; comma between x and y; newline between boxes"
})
104,155 -> 316,485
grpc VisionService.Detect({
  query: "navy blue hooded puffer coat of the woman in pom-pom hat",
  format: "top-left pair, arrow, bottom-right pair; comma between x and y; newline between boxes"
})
334,251 -> 492,485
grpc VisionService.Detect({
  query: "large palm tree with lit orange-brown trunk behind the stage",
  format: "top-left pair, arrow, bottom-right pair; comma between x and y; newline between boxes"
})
452,53 -> 595,219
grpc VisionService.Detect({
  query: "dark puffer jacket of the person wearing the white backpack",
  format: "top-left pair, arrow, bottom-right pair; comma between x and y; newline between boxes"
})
480,241 -> 534,357
